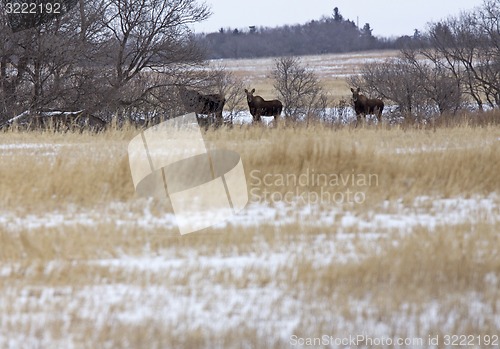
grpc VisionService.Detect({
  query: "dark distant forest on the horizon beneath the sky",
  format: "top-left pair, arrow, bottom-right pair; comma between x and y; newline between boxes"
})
197,7 -> 419,59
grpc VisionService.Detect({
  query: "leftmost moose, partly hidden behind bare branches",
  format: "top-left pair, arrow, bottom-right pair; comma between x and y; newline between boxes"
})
179,86 -> 226,127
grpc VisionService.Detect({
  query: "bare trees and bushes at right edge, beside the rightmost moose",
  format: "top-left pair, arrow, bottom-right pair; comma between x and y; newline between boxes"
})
351,0 -> 500,118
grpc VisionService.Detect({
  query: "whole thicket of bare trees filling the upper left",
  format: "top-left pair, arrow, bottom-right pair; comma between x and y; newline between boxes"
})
0,0 -> 210,126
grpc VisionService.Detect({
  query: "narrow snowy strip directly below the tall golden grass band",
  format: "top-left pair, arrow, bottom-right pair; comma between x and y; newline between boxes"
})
0,193 -> 500,238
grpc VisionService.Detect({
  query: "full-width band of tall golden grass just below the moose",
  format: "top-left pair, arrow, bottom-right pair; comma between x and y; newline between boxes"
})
0,116 -> 500,209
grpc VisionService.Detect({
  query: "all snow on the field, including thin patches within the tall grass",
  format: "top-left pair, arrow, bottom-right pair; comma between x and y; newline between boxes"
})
0,139 -> 500,348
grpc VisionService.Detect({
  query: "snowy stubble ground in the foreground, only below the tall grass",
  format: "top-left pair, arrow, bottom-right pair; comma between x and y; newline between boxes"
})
0,194 -> 500,348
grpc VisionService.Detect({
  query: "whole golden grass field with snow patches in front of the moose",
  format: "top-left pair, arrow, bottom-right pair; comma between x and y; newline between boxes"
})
0,114 -> 500,348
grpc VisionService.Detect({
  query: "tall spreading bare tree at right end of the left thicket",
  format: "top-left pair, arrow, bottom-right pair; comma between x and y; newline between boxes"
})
97,0 -> 210,121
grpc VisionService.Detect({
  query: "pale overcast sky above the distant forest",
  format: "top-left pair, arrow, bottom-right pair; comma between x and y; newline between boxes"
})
194,0 -> 483,37
